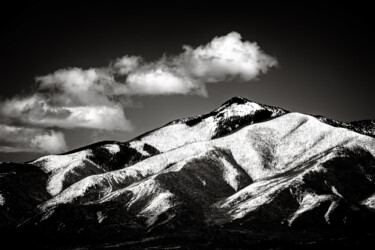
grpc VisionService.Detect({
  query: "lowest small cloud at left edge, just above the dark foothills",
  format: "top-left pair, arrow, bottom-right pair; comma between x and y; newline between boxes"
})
0,124 -> 67,154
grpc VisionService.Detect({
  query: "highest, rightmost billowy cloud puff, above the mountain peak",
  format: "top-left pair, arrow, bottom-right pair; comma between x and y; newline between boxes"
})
181,32 -> 277,82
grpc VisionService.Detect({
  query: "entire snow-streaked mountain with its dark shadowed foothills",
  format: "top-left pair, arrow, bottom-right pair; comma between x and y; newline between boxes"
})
0,97 -> 375,247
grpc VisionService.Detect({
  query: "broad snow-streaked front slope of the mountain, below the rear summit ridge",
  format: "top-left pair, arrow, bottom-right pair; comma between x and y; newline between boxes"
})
20,113 -> 375,239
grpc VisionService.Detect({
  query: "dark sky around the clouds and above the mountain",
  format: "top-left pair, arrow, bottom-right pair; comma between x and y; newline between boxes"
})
0,1 -> 375,161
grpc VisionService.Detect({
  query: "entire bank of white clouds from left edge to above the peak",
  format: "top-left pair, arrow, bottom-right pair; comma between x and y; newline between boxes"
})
0,32 -> 277,152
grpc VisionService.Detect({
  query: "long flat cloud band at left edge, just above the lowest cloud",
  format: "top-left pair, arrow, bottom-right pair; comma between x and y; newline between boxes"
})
0,95 -> 132,131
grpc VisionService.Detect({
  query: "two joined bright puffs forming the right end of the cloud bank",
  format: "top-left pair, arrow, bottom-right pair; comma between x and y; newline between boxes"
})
124,32 -> 277,96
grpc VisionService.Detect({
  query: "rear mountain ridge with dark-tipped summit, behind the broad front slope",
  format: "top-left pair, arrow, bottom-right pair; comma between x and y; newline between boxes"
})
31,97 -> 286,195
